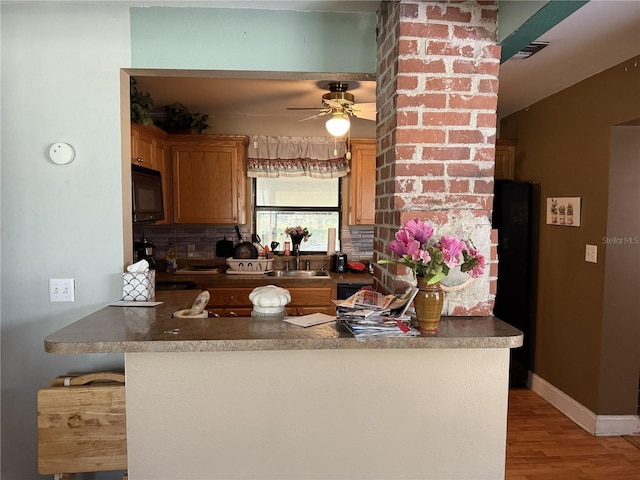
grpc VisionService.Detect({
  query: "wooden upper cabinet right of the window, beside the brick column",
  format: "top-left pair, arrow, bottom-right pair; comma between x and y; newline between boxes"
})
349,138 -> 376,225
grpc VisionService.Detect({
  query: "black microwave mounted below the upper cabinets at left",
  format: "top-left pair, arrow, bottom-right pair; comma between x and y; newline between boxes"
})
131,164 -> 164,223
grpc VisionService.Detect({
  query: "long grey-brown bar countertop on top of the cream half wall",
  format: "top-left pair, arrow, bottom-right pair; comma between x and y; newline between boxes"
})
44,290 -> 523,354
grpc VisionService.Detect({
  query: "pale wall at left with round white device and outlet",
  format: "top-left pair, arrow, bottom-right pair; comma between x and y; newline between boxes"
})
0,4 -> 130,480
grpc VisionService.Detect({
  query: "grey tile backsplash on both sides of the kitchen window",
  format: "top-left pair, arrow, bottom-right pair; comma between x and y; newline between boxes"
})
133,225 -> 373,265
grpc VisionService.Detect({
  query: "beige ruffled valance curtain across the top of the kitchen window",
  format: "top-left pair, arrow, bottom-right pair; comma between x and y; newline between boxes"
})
247,135 -> 349,178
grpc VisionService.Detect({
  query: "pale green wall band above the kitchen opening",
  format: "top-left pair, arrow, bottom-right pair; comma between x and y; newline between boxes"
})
131,6 -> 376,73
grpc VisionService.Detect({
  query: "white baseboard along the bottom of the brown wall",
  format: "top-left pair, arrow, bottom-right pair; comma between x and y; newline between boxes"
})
530,373 -> 640,436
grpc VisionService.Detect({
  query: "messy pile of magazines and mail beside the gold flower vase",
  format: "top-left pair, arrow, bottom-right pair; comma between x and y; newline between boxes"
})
336,287 -> 420,340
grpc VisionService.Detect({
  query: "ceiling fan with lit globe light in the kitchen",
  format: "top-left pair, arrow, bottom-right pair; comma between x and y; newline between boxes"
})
287,82 -> 376,137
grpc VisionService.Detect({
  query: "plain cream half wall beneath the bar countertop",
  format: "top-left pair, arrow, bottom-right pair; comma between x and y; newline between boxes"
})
126,348 -> 509,480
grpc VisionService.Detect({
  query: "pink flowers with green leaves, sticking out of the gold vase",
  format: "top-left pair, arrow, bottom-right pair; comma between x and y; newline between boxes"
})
378,218 -> 486,285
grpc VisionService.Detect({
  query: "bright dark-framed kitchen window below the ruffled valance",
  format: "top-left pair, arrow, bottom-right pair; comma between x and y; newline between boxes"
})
254,177 -> 340,253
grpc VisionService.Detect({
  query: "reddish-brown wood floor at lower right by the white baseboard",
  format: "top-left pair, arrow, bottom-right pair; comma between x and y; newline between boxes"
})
505,389 -> 640,480
